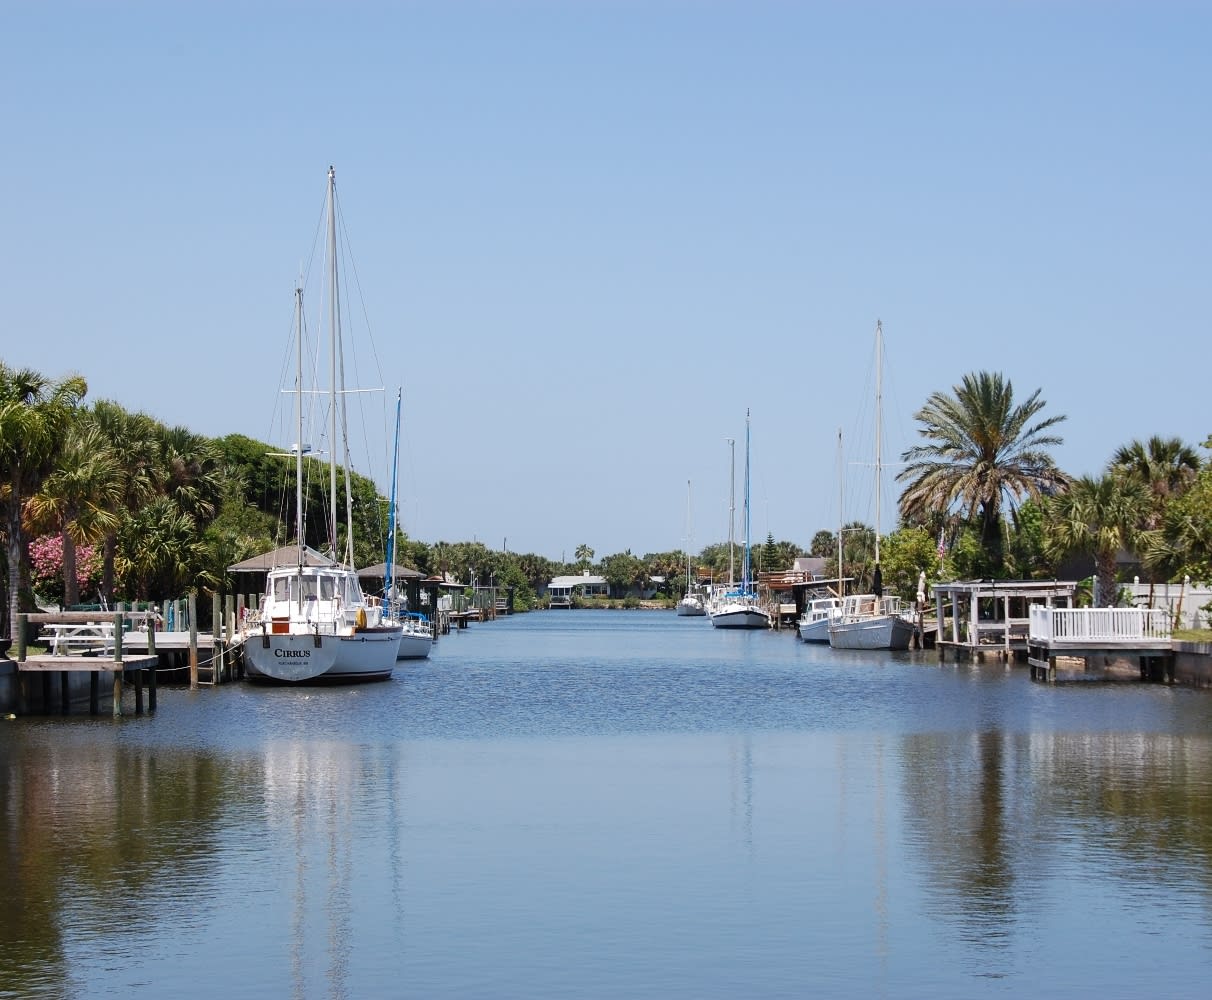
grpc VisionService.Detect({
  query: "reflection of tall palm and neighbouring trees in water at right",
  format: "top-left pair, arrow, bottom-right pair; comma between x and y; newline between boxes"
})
901,728 -> 1212,960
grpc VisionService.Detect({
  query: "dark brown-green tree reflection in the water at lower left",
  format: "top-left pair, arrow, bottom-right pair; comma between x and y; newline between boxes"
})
0,725 -> 238,996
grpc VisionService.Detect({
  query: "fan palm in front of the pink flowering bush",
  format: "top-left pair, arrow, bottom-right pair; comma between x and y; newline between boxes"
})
27,412 -> 122,606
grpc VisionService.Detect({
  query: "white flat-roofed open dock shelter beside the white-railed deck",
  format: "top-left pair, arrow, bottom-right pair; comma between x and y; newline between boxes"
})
932,579 -> 1077,659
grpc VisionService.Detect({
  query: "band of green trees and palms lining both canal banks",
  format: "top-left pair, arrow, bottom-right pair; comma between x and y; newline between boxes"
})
0,361 -> 1212,635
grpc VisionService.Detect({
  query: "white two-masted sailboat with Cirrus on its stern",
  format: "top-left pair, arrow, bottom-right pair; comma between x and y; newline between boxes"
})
244,167 -> 401,684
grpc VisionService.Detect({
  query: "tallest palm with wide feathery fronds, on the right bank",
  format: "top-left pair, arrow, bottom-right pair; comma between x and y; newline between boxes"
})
897,372 -> 1068,566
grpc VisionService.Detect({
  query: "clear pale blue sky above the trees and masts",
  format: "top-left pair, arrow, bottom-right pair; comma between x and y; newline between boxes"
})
0,0 -> 1212,560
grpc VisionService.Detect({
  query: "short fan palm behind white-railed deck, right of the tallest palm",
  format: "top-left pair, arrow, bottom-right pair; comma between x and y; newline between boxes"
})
1045,474 -> 1149,607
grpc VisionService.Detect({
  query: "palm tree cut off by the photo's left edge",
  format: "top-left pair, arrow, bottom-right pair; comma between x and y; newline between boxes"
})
0,361 -> 88,638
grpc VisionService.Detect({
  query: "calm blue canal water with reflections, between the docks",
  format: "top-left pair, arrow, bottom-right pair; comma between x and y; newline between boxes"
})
0,612 -> 1212,1000
